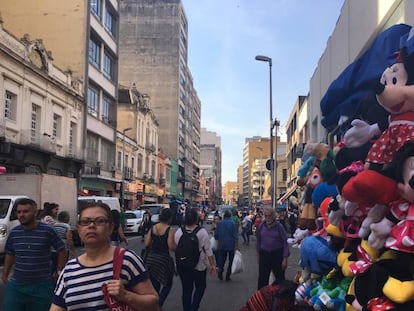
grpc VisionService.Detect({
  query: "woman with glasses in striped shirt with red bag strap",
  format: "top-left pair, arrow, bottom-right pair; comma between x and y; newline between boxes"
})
50,202 -> 158,311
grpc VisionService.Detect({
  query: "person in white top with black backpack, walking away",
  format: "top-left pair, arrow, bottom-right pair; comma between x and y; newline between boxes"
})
174,208 -> 216,311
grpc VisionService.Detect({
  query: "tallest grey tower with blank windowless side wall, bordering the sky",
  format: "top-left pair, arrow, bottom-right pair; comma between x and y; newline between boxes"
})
119,0 -> 201,200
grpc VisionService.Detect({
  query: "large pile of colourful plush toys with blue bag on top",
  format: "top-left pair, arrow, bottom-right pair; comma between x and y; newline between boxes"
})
296,24 -> 414,311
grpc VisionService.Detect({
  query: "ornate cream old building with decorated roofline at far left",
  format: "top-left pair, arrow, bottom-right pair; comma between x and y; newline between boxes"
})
0,20 -> 85,178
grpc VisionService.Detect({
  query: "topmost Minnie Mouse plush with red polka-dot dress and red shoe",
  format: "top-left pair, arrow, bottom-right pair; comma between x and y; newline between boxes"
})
342,39 -> 414,213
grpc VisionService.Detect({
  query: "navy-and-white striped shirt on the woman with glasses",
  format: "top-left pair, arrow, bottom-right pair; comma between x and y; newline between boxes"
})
53,250 -> 149,310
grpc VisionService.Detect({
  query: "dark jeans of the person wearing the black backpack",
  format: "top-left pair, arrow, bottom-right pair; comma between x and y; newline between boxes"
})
177,269 -> 207,311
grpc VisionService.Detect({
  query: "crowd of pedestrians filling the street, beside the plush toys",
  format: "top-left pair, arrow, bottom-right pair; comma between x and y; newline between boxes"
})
2,199 -> 289,311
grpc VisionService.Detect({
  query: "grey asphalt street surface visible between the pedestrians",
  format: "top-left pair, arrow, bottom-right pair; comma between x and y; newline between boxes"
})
0,225 -> 300,311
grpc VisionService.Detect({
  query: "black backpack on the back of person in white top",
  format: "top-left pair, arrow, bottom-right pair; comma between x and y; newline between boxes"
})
175,226 -> 201,270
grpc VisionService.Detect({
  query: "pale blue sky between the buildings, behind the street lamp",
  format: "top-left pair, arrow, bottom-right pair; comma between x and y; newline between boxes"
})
182,0 -> 344,185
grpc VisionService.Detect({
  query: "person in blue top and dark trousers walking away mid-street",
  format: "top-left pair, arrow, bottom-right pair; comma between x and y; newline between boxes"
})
214,211 -> 239,281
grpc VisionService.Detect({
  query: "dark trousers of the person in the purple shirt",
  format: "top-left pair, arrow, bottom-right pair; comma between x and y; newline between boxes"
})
257,248 -> 285,290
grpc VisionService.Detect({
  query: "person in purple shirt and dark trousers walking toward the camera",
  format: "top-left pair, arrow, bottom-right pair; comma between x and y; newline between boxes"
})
256,207 -> 290,289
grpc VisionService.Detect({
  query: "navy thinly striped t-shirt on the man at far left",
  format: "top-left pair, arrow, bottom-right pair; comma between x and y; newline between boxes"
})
5,222 -> 65,283
